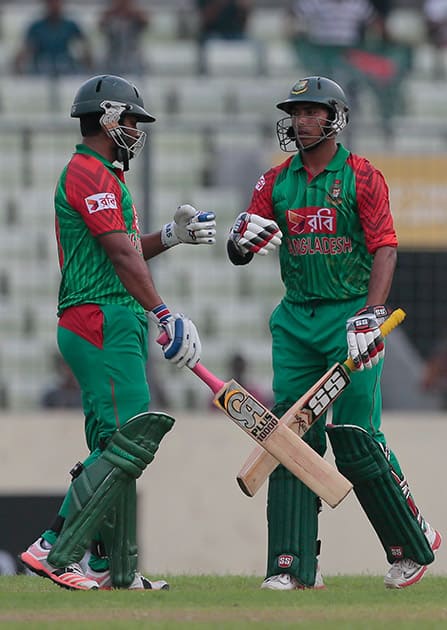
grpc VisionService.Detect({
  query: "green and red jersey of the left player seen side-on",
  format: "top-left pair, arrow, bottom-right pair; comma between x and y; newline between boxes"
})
55,144 -> 144,315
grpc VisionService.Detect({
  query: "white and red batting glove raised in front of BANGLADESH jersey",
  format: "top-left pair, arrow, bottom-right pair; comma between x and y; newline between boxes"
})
229,212 -> 282,256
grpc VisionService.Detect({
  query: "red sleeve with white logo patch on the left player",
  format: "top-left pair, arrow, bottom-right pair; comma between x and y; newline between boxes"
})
65,154 -> 127,236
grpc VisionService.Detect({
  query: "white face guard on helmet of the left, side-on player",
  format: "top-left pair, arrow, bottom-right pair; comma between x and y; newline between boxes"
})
99,100 -> 147,170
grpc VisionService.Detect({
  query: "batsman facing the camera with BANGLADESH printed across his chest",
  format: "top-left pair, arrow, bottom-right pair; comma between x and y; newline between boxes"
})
228,76 -> 441,590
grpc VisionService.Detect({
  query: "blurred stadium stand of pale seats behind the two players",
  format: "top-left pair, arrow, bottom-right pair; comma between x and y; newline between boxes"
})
0,0 -> 446,409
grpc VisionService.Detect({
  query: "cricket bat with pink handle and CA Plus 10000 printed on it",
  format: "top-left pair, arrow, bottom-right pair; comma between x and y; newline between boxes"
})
157,335 -> 352,507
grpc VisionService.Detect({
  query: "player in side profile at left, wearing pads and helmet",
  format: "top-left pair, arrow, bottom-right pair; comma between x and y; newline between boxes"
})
21,75 -> 215,590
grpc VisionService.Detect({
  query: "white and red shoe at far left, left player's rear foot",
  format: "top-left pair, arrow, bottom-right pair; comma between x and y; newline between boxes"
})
20,538 -> 99,591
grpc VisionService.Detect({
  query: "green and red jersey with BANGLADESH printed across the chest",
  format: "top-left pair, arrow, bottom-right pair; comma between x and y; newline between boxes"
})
247,144 -> 397,303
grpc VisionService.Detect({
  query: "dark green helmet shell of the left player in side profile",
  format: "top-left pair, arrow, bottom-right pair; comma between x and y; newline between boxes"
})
71,74 -> 155,122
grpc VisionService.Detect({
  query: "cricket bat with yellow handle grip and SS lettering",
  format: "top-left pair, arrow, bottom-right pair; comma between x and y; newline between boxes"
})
237,308 -> 405,497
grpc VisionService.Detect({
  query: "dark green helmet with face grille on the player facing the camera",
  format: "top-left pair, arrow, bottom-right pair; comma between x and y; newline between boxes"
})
276,76 -> 349,151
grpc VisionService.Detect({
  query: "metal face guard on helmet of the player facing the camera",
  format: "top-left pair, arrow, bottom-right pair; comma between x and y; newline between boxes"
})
276,101 -> 348,153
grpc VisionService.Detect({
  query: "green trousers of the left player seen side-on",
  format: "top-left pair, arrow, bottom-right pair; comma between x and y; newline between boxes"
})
44,304 -> 150,556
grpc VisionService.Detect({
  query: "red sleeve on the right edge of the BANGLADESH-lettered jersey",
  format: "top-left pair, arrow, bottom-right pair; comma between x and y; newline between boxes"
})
348,154 -> 398,254
